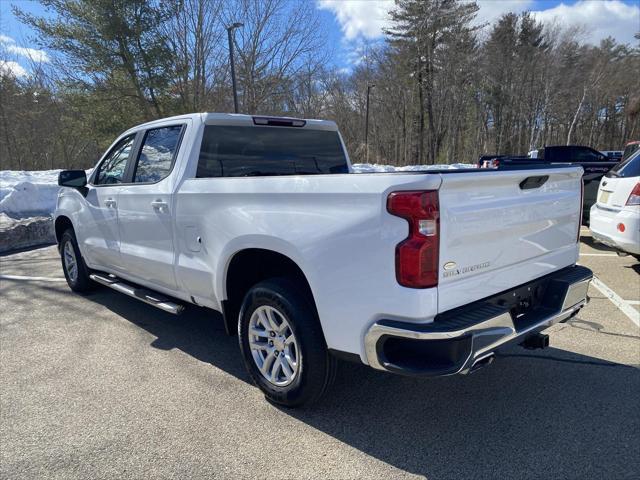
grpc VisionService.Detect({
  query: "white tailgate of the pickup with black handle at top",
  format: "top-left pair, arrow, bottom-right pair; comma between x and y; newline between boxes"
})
438,167 -> 582,312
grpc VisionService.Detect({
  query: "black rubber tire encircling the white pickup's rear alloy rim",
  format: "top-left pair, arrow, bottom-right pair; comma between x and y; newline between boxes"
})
238,278 -> 337,408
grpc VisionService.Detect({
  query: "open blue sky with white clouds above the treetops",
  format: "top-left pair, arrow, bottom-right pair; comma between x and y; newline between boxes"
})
0,0 -> 640,75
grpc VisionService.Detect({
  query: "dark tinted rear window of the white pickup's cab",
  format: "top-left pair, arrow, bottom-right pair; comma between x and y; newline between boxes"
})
196,125 -> 349,178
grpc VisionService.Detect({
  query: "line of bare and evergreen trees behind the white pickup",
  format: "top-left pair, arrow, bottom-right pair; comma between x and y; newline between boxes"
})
0,0 -> 640,169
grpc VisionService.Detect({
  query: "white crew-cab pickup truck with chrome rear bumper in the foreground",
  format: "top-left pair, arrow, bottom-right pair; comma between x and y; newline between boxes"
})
55,113 -> 592,406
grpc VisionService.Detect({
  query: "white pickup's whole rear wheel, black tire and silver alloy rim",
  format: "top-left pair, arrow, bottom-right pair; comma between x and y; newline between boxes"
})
238,278 -> 336,407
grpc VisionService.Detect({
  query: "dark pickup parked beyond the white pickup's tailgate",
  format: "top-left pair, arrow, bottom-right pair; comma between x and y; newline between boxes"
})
484,145 -> 619,224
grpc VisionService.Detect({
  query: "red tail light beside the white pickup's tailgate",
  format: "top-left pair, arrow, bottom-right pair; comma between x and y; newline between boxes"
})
387,190 -> 440,288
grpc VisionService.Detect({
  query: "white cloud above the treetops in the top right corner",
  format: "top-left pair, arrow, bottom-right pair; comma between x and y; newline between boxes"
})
532,0 -> 640,44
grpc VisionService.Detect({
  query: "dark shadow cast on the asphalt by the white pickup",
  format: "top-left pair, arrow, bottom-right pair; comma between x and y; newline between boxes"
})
87,289 -> 640,479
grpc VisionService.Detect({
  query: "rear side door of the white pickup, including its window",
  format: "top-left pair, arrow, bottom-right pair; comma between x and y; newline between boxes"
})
118,121 -> 187,290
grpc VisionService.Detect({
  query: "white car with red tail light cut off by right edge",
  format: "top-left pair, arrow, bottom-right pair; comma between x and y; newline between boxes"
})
589,150 -> 640,260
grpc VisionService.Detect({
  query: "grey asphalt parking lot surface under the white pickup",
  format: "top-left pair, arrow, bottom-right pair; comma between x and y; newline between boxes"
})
0,234 -> 640,479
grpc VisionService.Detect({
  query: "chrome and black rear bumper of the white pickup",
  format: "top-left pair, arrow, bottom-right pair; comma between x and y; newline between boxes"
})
365,266 -> 593,376
